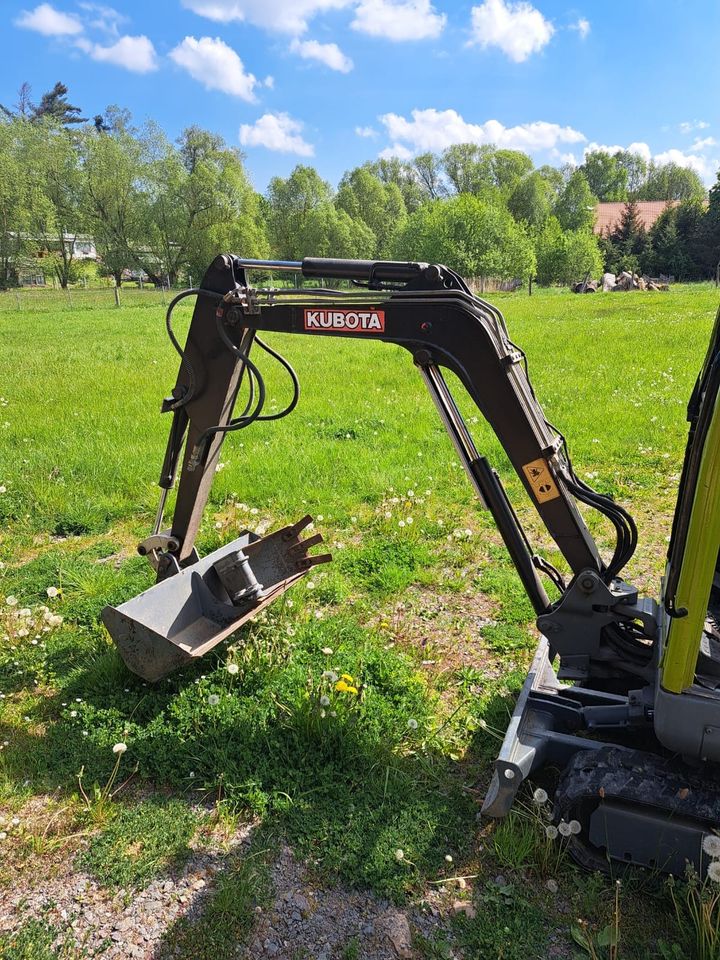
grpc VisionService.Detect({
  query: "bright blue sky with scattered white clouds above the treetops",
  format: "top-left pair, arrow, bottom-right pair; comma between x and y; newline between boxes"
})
0,0 -> 720,190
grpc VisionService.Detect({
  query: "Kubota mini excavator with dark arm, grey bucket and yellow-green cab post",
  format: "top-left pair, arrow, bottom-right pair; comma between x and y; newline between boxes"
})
102,255 -> 720,876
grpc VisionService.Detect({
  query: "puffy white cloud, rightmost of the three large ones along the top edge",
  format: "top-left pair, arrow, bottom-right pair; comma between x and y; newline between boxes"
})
470,0 -> 555,63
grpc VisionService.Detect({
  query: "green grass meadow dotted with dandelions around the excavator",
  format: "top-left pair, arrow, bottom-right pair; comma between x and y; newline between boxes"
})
0,285 -> 719,960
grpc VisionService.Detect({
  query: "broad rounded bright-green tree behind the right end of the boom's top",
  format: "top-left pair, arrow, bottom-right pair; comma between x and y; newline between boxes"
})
396,194 -> 535,279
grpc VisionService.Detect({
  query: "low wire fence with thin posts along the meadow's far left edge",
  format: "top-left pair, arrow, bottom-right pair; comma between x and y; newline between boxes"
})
0,286 -> 176,314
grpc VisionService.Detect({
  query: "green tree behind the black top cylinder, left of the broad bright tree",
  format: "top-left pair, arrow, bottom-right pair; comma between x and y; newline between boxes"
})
335,167 -> 407,259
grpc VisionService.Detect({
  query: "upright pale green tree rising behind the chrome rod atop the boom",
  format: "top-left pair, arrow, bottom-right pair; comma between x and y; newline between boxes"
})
267,164 -> 332,260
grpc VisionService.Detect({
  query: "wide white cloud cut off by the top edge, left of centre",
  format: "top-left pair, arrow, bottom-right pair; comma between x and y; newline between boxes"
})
182,0 -> 351,34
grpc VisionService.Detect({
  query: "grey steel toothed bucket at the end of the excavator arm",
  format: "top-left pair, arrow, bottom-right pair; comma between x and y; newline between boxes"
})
102,516 -> 332,681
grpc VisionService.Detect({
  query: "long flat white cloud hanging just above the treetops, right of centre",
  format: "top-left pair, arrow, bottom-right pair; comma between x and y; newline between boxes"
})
380,108 -> 585,156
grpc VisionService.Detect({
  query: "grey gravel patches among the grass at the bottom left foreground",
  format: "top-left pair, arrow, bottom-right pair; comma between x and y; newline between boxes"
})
0,812 -> 462,960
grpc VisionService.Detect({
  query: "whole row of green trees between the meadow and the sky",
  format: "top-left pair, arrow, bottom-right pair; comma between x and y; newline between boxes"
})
0,84 -> 720,287
